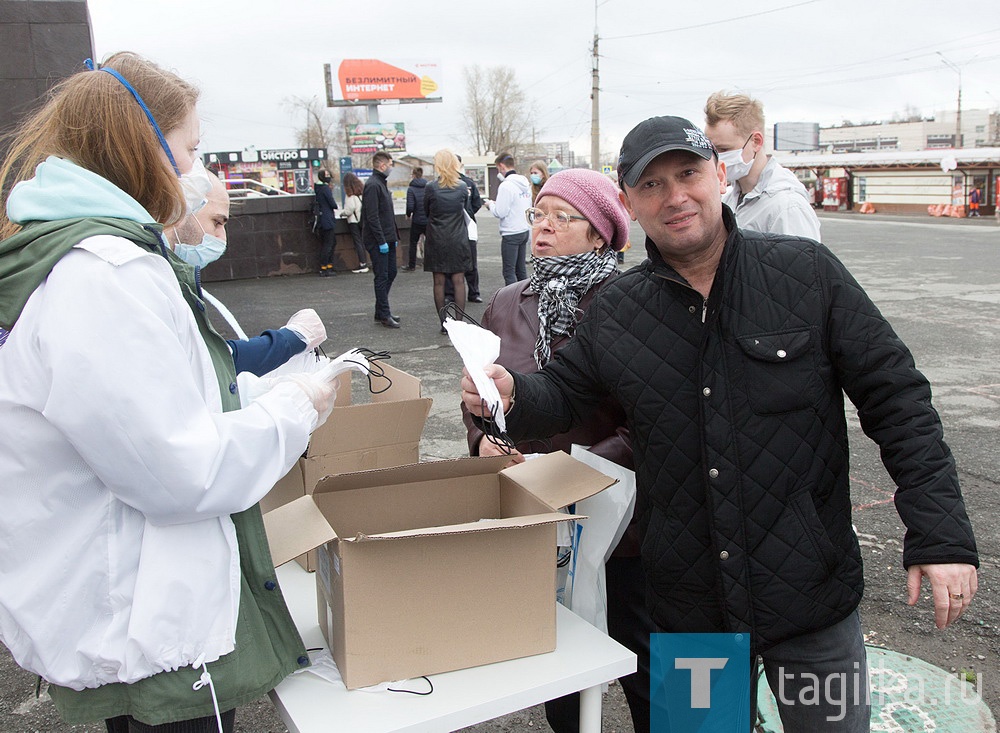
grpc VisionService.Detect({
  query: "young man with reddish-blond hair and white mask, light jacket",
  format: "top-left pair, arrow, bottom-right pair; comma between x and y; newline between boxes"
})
705,92 -> 820,242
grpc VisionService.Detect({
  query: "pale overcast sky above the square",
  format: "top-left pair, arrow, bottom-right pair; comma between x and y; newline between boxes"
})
88,0 -> 1000,158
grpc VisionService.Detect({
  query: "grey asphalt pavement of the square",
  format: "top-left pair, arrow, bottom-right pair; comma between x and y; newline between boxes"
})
0,209 -> 1000,733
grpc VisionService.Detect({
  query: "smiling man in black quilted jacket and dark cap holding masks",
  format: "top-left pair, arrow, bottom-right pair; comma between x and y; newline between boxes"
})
462,117 -> 979,733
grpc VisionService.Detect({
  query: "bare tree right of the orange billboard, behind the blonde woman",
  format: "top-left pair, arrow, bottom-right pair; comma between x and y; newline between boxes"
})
465,65 -> 530,157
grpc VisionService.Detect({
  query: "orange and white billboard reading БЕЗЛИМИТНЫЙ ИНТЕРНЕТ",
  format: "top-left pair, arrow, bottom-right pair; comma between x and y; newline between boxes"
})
324,59 -> 441,107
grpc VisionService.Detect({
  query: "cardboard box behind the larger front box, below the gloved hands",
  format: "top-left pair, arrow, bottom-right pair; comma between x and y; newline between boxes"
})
260,362 -> 431,572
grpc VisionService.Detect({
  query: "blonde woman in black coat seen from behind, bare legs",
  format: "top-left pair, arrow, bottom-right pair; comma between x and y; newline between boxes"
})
424,150 -> 471,333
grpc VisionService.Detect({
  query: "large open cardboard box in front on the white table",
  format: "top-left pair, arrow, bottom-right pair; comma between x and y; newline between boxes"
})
264,453 -> 614,689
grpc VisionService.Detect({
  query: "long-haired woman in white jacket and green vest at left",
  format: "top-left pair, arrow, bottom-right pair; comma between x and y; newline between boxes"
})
0,53 -> 334,733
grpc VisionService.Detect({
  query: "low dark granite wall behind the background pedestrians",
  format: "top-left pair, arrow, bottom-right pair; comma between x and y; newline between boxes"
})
202,194 -> 410,282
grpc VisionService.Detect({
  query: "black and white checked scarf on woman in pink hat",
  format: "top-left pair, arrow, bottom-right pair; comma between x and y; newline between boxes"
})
530,247 -> 618,369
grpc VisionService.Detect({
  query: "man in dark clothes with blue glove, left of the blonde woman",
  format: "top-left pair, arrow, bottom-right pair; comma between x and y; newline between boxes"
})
361,152 -> 399,328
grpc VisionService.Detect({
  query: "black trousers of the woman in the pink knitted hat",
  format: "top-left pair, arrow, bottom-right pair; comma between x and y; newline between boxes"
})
545,557 -> 656,733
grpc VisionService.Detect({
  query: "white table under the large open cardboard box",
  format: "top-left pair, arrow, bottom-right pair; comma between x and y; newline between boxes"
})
271,562 -> 636,733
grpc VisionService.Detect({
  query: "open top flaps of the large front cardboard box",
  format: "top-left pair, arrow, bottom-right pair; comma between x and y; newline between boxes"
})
264,451 -> 615,567
